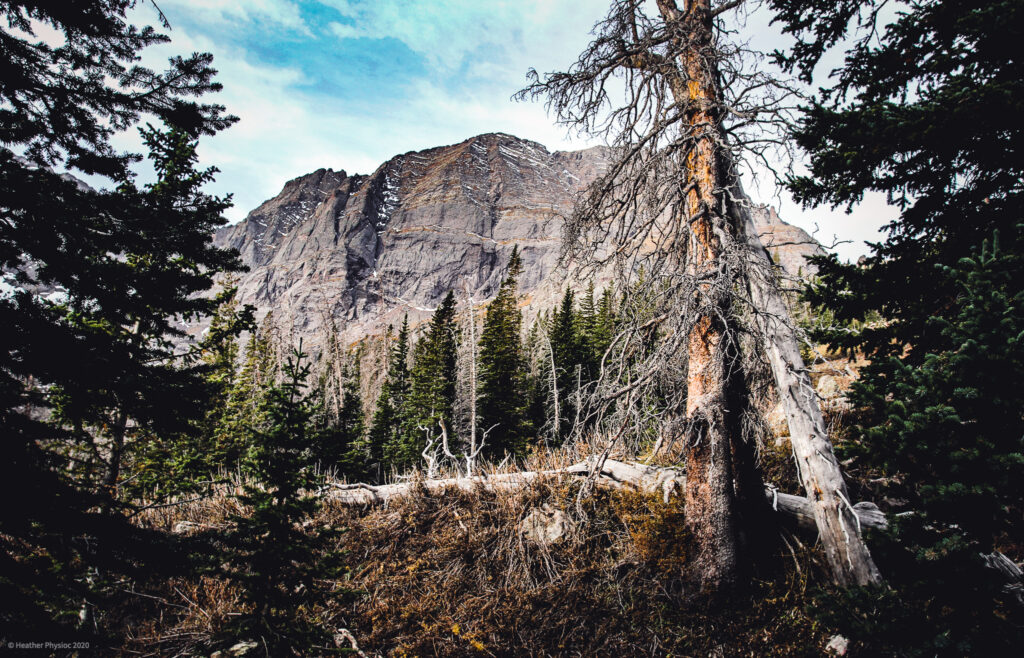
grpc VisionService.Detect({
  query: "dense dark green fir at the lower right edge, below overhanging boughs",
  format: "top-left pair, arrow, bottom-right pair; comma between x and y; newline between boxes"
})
815,226 -> 1024,656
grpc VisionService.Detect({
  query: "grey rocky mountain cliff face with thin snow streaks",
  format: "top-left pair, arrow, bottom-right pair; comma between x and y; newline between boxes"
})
216,134 -> 820,340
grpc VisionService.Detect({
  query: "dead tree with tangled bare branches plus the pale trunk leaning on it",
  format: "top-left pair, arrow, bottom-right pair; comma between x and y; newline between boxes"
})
520,0 -> 882,589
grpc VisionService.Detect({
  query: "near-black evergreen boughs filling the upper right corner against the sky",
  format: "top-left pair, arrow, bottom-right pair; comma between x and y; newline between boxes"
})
769,0 -> 1024,362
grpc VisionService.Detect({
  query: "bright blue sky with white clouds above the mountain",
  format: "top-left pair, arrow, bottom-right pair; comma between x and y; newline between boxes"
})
118,0 -> 895,259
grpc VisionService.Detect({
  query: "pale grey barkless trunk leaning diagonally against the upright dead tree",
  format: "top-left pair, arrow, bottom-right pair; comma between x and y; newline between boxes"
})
733,199 -> 883,585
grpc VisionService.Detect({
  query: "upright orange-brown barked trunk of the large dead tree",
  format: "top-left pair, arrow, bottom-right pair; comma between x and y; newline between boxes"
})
657,0 -> 739,590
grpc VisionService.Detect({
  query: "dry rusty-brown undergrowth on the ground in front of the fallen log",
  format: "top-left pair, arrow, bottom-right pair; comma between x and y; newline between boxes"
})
109,460 -> 856,656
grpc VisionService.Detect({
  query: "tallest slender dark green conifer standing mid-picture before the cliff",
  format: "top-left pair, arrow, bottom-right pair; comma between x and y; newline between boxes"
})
479,247 -> 525,457
